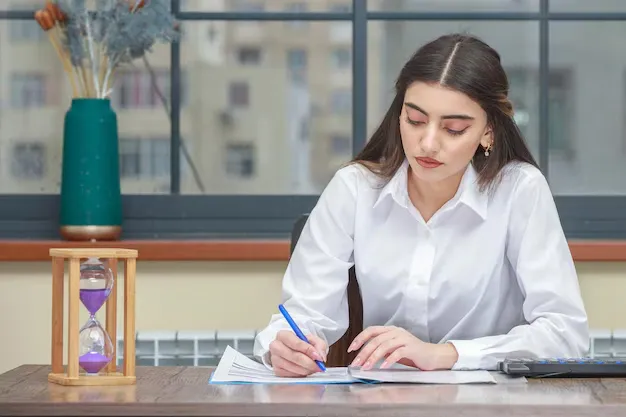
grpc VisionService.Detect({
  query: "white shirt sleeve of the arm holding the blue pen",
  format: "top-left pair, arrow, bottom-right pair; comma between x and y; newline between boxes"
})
254,167 -> 357,366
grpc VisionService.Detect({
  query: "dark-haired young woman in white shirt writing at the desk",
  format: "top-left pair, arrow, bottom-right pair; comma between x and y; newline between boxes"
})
255,34 -> 589,376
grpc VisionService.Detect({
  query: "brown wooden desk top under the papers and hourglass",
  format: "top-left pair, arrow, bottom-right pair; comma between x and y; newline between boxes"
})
0,365 -> 626,417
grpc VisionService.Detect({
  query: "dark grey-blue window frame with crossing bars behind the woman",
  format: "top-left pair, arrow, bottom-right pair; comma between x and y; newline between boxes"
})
0,0 -> 626,239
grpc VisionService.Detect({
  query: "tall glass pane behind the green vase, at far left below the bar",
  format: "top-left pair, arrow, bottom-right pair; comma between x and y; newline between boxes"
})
0,15 -> 170,194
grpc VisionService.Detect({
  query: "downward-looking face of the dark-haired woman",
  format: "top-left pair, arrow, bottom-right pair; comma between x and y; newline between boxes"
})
400,82 -> 492,183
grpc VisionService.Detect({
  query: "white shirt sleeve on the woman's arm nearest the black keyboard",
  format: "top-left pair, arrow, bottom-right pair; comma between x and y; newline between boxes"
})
449,171 -> 589,370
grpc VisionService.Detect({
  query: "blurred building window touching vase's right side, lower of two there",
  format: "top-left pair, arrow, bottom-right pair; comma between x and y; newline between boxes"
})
120,138 -> 170,179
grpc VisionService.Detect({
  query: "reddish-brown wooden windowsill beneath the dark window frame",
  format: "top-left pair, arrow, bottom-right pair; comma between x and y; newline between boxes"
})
0,240 -> 626,262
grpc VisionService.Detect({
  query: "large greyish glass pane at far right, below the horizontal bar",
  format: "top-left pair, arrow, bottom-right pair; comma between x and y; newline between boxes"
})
549,22 -> 626,195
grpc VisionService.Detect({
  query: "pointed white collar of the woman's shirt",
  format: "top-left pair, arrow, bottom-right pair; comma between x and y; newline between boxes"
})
374,159 -> 489,220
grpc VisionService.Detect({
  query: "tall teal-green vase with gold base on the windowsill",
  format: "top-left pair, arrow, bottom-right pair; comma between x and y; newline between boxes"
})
60,98 -> 122,240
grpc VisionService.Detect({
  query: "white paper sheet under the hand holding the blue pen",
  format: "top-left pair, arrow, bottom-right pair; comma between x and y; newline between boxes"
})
209,346 -> 358,384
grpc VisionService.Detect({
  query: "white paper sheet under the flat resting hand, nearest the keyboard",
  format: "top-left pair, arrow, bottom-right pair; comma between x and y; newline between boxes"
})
349,365 -> 496,384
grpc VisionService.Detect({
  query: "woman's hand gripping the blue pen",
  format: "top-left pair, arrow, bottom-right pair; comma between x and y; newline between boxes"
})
270,330 -> 328,377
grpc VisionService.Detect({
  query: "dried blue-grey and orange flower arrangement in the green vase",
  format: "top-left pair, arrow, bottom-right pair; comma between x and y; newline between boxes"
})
35,0 -> 179,98
